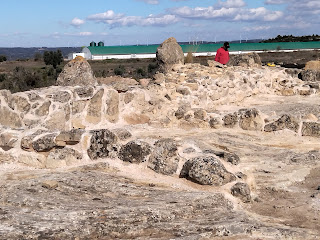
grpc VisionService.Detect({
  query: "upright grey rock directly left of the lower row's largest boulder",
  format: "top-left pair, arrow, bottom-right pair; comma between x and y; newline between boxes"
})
148,138 -> 179,175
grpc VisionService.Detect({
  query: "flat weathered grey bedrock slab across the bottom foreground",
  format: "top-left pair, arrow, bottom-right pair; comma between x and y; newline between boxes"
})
0,168 -> 312,239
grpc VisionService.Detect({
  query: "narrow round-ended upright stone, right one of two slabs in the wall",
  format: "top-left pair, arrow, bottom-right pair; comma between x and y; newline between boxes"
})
106,90 -> 119,123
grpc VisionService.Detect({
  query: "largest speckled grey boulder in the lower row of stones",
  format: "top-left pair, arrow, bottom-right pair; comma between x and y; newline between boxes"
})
180,156 -> 236,186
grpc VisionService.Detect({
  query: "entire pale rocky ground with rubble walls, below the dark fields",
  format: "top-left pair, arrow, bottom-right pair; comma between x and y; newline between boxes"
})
0,46 -> 320,240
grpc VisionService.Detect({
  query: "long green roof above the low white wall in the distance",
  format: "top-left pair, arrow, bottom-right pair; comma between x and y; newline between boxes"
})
88,42 -> 320,54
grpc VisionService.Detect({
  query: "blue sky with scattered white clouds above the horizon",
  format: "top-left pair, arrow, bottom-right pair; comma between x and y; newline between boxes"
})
0,0 -> 320,47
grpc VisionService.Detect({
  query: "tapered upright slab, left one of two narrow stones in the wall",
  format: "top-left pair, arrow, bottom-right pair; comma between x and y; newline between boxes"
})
86,89 -> 104,123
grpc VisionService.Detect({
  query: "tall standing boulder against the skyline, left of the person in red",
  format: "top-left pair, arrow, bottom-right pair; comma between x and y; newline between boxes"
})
156,37 -> 184,73
